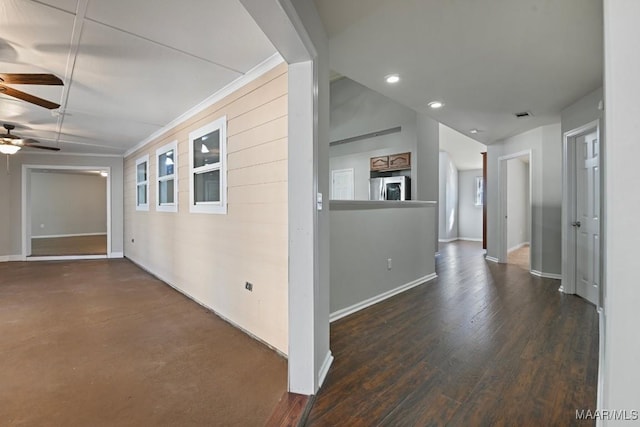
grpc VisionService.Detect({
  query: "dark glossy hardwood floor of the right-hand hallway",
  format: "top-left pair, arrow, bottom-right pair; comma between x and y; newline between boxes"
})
306,242 -> 598,426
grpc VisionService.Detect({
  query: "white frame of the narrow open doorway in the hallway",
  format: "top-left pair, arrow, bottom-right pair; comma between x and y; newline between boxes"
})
498,149 -> 534,271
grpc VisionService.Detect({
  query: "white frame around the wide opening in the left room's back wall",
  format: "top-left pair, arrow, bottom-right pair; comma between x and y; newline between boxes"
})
21,165 -> 111,261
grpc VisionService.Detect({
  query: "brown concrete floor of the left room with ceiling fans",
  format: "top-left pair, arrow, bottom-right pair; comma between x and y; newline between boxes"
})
0,260 -> 287,426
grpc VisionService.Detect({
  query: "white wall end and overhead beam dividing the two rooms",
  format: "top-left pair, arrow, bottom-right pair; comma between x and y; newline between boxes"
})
240,0 -> 333,394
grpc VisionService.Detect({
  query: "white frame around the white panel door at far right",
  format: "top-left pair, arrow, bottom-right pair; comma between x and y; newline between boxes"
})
560,119 -> 604,300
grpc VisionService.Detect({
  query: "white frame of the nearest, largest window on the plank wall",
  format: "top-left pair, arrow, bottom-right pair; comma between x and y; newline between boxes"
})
189,116 -> 227,215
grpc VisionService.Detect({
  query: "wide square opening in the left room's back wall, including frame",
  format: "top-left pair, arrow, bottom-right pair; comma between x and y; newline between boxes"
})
22,165 -> 111,261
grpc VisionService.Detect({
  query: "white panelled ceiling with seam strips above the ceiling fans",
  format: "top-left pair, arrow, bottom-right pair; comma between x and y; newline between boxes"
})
0,0 -> 276,154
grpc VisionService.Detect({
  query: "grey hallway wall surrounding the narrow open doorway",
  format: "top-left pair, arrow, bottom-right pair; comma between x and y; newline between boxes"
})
487,123 -> 562,277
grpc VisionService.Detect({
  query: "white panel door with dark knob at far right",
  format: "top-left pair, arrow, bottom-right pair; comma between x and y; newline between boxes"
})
573,132 -> 600,305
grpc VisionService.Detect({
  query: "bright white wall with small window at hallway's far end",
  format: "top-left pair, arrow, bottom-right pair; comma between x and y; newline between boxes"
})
458,169 -> 482,241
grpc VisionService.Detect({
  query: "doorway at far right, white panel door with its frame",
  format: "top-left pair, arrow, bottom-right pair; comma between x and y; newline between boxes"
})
561,121 -> 602,307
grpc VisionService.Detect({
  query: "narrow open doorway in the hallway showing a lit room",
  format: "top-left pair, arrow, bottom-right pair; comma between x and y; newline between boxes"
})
498,150 -> 532,271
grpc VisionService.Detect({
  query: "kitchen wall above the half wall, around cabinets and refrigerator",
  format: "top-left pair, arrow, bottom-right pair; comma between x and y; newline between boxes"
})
329,77 -> 417,200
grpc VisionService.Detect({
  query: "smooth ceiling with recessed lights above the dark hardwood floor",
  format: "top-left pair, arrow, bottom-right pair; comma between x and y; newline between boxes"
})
315,0 -> 603,143
